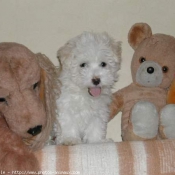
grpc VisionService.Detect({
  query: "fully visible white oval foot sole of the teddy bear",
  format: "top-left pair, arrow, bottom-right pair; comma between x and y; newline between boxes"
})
131,101 -> 159,139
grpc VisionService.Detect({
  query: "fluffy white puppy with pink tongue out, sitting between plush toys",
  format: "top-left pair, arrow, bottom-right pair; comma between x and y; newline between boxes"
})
56,32 -> 121,145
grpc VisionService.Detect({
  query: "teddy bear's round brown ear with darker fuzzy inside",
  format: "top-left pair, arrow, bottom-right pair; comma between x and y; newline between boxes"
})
128,23 -> 152,50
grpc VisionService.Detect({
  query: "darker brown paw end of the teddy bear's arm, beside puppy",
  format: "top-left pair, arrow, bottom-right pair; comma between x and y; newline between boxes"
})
110,91 -> 124,120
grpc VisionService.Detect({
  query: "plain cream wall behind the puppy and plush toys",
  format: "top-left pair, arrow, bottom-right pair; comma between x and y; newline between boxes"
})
0,0 -> 175,141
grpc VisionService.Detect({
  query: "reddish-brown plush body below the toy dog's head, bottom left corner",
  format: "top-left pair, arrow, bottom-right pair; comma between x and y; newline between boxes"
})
0,117 -> 40,174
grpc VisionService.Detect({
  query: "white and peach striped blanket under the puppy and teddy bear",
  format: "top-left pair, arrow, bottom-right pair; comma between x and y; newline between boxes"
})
35,140 -> 175,175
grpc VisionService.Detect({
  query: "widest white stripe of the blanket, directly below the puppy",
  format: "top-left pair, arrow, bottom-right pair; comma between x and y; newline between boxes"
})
69,143 -> 119,175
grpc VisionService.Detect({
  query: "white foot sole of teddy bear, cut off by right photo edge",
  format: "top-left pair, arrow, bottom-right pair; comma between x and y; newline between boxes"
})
160,104 -> 175,139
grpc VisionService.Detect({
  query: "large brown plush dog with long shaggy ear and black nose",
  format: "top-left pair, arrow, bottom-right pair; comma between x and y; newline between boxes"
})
0,43 -> 60,174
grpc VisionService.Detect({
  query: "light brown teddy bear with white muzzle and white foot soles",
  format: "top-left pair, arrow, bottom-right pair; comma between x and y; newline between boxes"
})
111,23 -> 175,141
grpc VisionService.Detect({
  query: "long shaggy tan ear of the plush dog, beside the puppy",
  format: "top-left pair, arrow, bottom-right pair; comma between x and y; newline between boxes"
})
32,53 -> 61,149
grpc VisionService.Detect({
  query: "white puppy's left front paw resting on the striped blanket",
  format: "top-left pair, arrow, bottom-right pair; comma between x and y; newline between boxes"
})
56,137 -> 82,146
